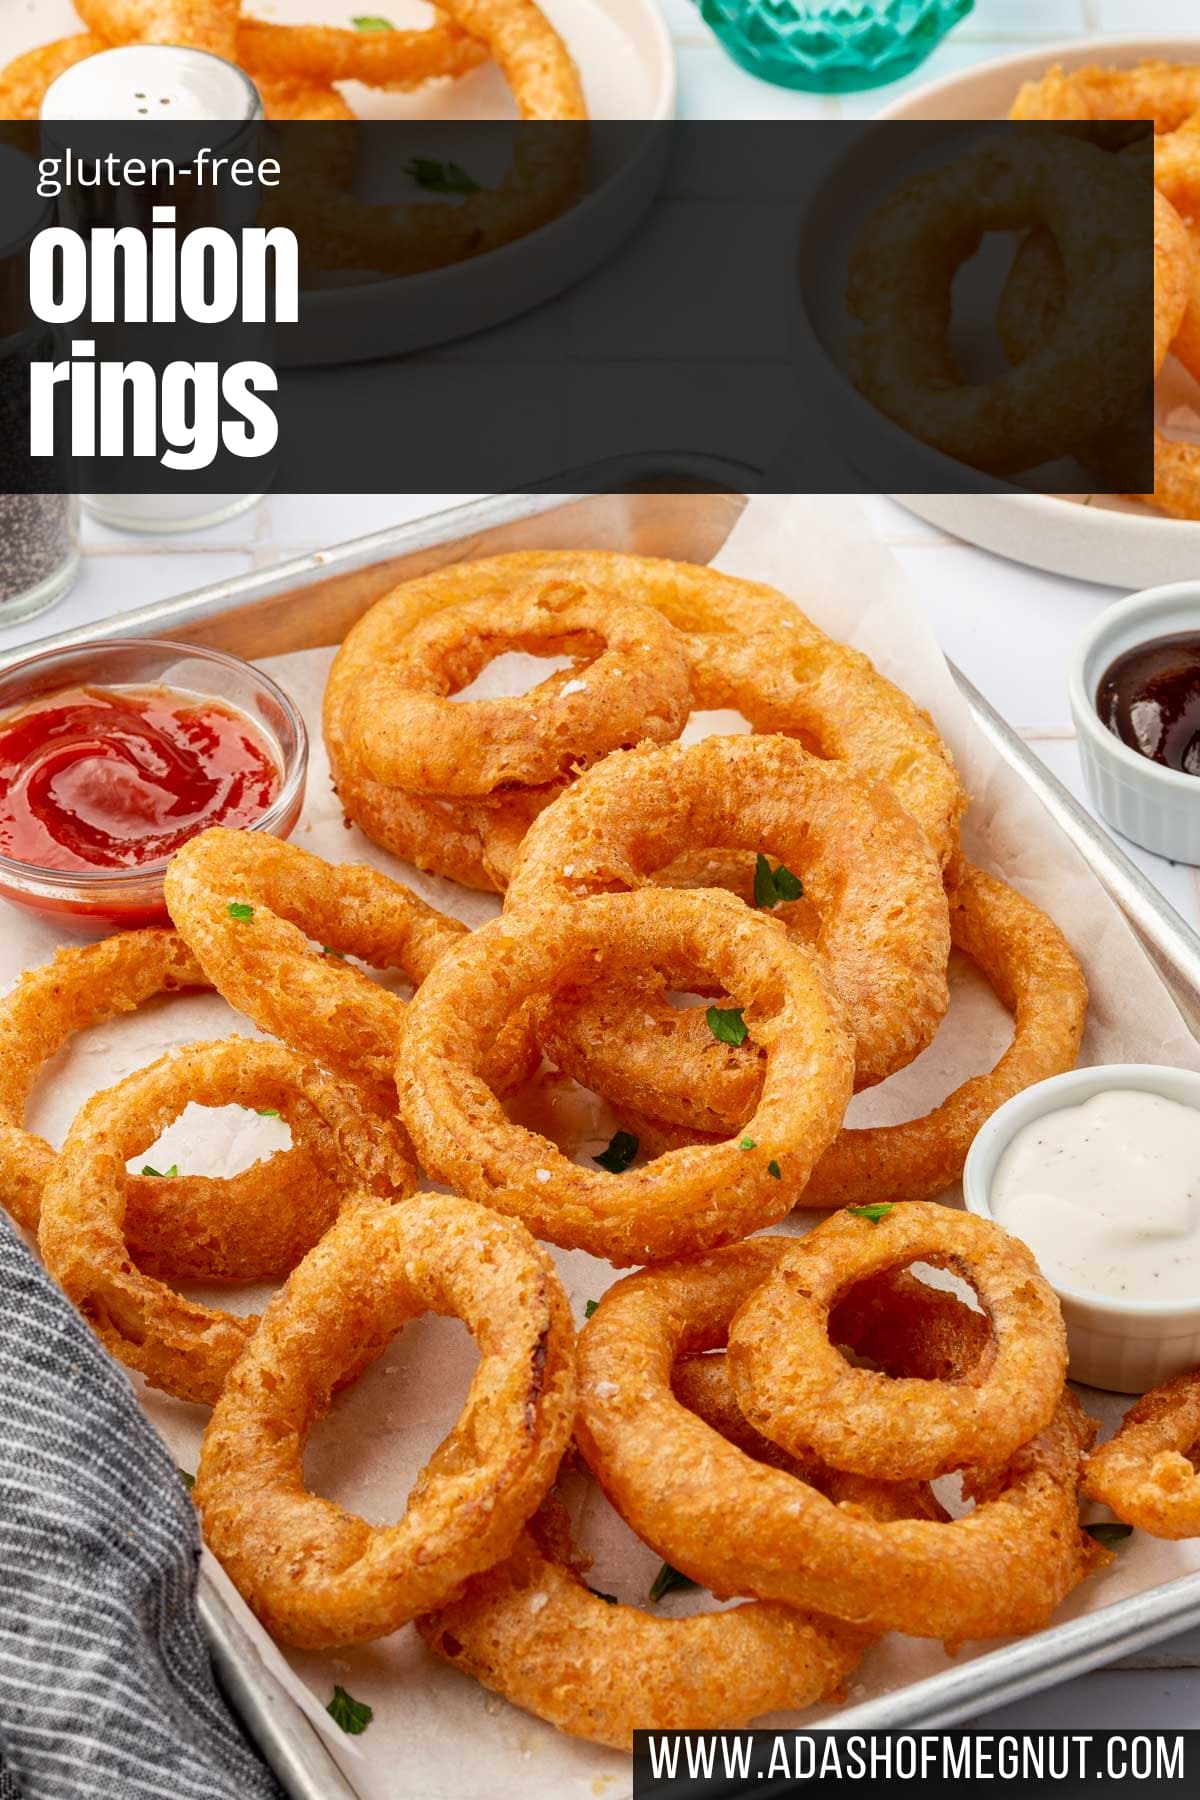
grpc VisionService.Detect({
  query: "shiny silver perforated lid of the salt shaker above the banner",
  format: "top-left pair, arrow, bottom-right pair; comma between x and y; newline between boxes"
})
41,43 -> 263,126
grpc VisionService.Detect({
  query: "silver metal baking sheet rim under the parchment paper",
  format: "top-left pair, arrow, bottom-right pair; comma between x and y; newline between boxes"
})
0,471 -> 1200,1778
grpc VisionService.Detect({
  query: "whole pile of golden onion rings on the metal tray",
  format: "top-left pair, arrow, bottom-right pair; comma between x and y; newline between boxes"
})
0,536 -> 1129,1748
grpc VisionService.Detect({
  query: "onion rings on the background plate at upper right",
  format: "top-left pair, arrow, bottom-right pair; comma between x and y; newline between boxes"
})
847,61 -> 1200,518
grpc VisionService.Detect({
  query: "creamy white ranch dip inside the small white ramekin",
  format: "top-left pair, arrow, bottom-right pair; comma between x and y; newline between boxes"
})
990,1087 -> 1200,1300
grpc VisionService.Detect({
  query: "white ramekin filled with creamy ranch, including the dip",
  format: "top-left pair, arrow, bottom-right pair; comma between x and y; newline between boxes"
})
963,1062 -> 1200,1393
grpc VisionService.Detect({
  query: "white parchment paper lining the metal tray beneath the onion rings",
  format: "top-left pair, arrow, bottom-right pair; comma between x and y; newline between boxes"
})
14,497 -> 1200,1800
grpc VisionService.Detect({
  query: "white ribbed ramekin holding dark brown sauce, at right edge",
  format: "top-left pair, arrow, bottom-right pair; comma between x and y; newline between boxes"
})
1067,580 -> 1200,864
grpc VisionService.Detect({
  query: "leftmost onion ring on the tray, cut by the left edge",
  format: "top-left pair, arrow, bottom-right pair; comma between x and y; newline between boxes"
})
0,931 -> 336,1282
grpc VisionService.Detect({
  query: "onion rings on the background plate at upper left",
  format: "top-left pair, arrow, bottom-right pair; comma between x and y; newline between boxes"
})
0,0 -> 588,275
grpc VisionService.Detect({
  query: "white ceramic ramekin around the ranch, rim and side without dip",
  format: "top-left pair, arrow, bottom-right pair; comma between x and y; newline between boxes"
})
963,1062 -> 1200,1393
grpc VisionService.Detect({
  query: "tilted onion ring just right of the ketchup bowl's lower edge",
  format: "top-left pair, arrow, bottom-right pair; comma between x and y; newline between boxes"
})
164,824 -> 534,1098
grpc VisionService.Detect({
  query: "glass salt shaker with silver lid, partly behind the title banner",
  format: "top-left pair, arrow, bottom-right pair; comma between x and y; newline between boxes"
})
41,43 -> 263,535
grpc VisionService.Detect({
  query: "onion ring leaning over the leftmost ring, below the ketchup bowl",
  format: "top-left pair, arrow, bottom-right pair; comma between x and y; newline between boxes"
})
38,1039 -> 417,1404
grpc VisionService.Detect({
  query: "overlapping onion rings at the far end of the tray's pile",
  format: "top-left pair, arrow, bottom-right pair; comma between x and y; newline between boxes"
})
324,551 -> 966,891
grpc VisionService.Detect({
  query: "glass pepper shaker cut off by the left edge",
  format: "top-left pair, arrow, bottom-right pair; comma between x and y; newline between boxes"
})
0,144 -> 79,630
